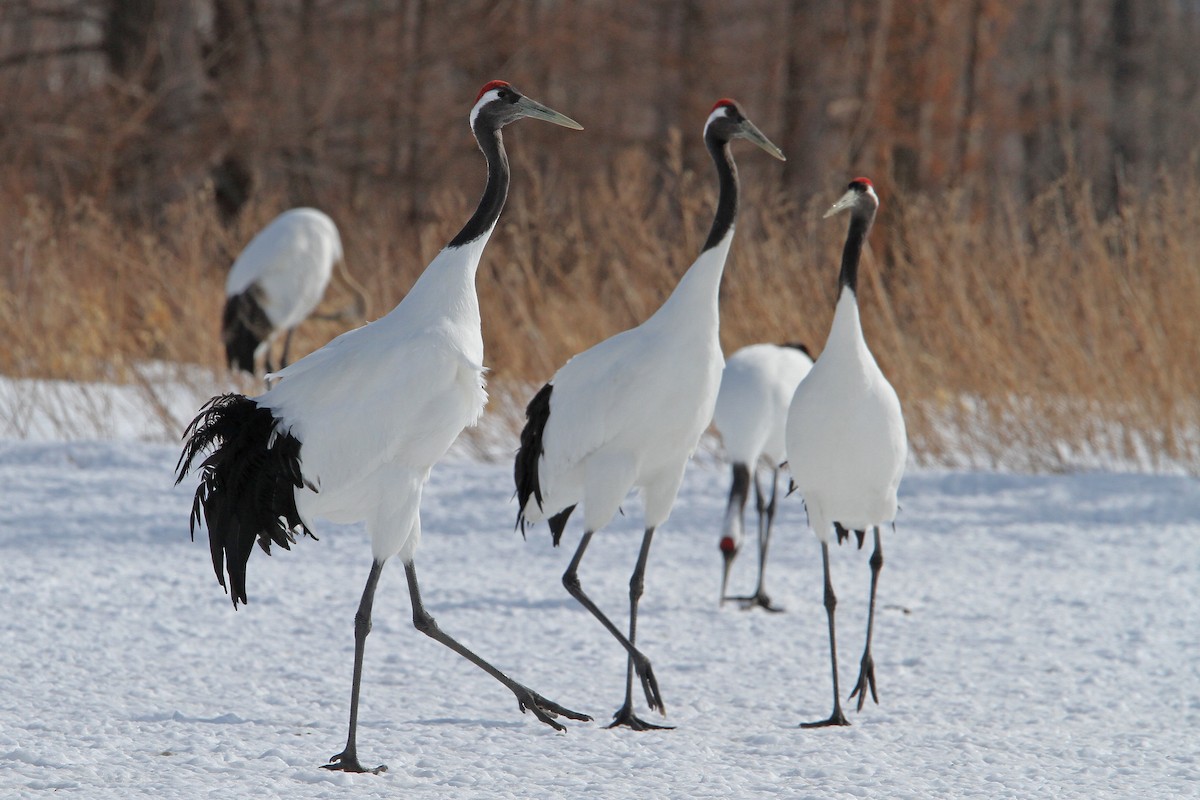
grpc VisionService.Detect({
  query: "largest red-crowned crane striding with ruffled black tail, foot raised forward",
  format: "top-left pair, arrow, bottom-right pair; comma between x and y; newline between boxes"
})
176,80 -> 589,772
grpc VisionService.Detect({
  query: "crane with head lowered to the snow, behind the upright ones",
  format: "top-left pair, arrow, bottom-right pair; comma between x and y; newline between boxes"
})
713,343 -> 812,612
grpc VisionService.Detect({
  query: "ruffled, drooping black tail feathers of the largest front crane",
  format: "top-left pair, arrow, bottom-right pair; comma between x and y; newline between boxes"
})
175,395 -> 316,608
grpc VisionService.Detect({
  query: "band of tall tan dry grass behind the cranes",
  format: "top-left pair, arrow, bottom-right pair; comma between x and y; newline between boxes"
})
0,151 -> 1200,471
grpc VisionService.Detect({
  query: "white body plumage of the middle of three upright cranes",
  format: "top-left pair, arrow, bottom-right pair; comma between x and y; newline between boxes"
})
524,239 -> 733,530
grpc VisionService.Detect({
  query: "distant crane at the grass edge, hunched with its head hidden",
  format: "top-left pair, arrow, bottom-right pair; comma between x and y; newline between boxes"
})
221,209 -> 366,374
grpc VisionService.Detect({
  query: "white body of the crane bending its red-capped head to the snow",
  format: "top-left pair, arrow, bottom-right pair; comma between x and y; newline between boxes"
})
713,343 -> 812,471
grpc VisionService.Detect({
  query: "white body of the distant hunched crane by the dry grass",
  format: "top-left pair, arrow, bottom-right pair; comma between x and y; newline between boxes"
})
226,209 -> 342,332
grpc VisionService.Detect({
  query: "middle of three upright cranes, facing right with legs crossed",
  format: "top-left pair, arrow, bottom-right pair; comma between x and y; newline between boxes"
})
514,100 -> 784,730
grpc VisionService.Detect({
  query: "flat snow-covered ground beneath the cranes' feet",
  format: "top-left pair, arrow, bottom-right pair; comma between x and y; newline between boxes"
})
0,379 -> 1200,799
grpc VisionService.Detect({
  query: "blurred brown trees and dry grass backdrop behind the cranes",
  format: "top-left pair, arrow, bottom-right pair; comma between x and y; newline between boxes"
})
0,0 -> 1200,471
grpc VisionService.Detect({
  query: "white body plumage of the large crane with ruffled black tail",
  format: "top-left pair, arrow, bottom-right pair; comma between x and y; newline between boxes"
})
258,231 -> 494,563
